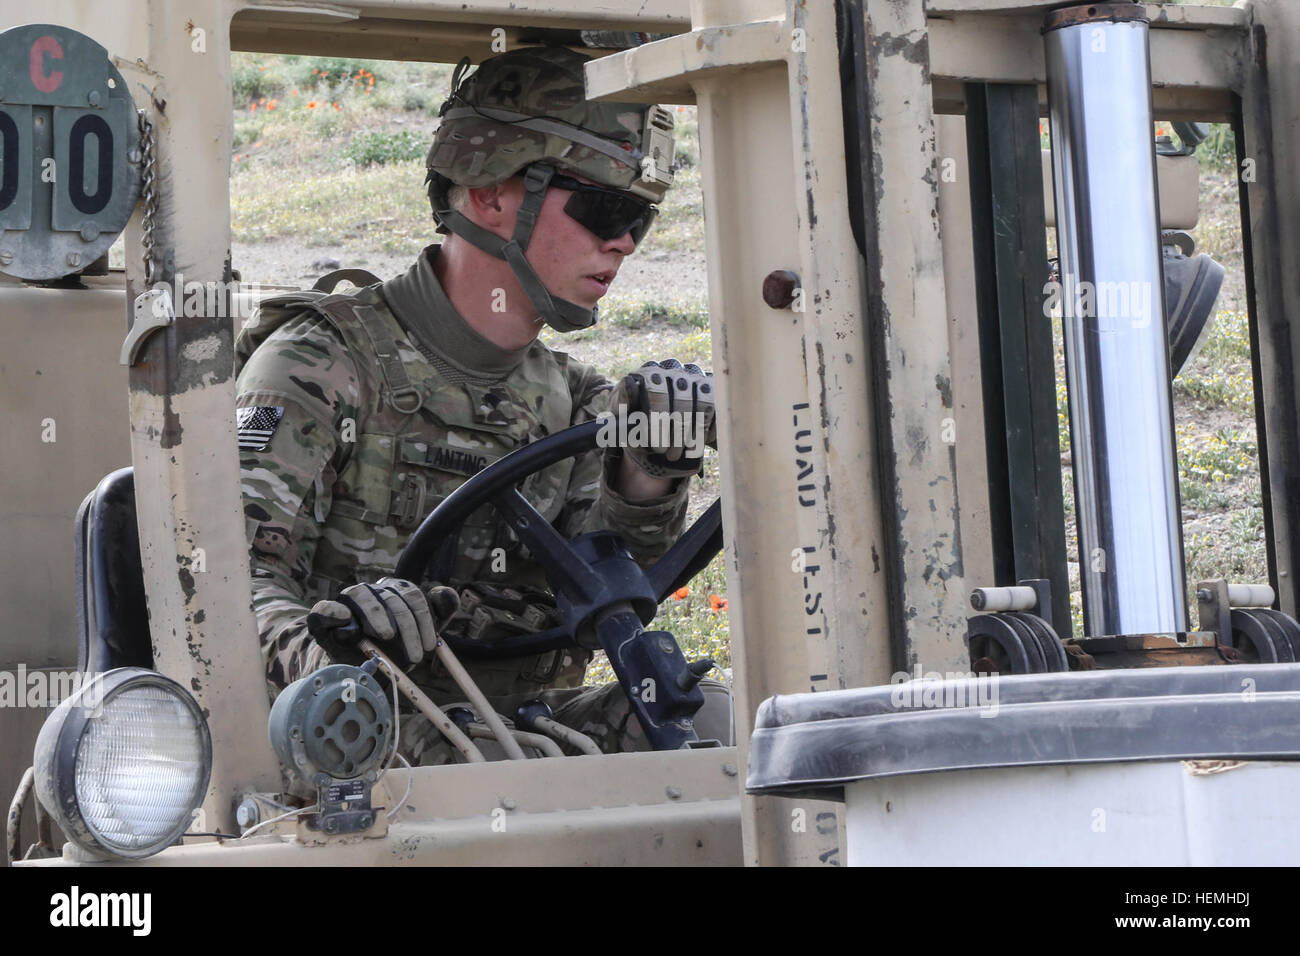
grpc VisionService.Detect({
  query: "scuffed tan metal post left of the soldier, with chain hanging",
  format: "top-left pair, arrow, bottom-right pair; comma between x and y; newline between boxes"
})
122,0 -> 280,831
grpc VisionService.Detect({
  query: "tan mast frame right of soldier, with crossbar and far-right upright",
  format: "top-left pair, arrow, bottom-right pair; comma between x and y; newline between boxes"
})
588,0 -> 1300,862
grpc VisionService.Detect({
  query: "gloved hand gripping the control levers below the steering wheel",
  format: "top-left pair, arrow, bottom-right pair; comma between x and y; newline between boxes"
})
307,578 -> 455,670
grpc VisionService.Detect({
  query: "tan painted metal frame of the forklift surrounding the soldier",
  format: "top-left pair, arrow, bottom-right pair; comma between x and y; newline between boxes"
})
0,0 -> 1300,865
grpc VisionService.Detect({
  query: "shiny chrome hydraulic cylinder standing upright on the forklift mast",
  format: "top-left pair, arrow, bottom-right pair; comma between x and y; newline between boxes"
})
1044,3 -> 1187,636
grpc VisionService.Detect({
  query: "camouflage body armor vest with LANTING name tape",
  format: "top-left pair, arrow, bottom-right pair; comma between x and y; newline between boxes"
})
235,286 -> 590,700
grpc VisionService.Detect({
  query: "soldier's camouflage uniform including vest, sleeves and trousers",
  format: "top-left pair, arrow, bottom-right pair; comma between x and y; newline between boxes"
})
237,246 -> 688,762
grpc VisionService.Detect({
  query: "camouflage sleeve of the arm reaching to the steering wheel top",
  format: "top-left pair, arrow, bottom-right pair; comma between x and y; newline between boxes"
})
560,362 -> 690,564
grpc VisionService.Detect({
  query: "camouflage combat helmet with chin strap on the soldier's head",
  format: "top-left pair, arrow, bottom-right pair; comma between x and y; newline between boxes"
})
425,47 -> 673,332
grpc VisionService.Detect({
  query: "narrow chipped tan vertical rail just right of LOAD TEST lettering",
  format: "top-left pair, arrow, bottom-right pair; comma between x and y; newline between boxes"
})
865,0 -> 967,670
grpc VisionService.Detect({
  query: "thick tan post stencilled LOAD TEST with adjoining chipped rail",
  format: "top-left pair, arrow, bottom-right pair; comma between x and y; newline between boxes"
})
588,0 -> 979,864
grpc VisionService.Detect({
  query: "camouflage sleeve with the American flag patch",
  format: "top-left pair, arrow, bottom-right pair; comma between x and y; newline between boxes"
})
235,313 -> 360,687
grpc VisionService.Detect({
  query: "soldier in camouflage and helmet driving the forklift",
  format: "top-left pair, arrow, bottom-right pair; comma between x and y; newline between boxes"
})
237,47 -> 729,763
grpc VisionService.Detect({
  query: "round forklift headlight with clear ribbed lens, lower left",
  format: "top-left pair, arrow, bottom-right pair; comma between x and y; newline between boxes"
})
34,667 -> 212,860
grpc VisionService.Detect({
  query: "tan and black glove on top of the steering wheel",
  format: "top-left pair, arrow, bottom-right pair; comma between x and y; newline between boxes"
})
610,359 -> 718,477
